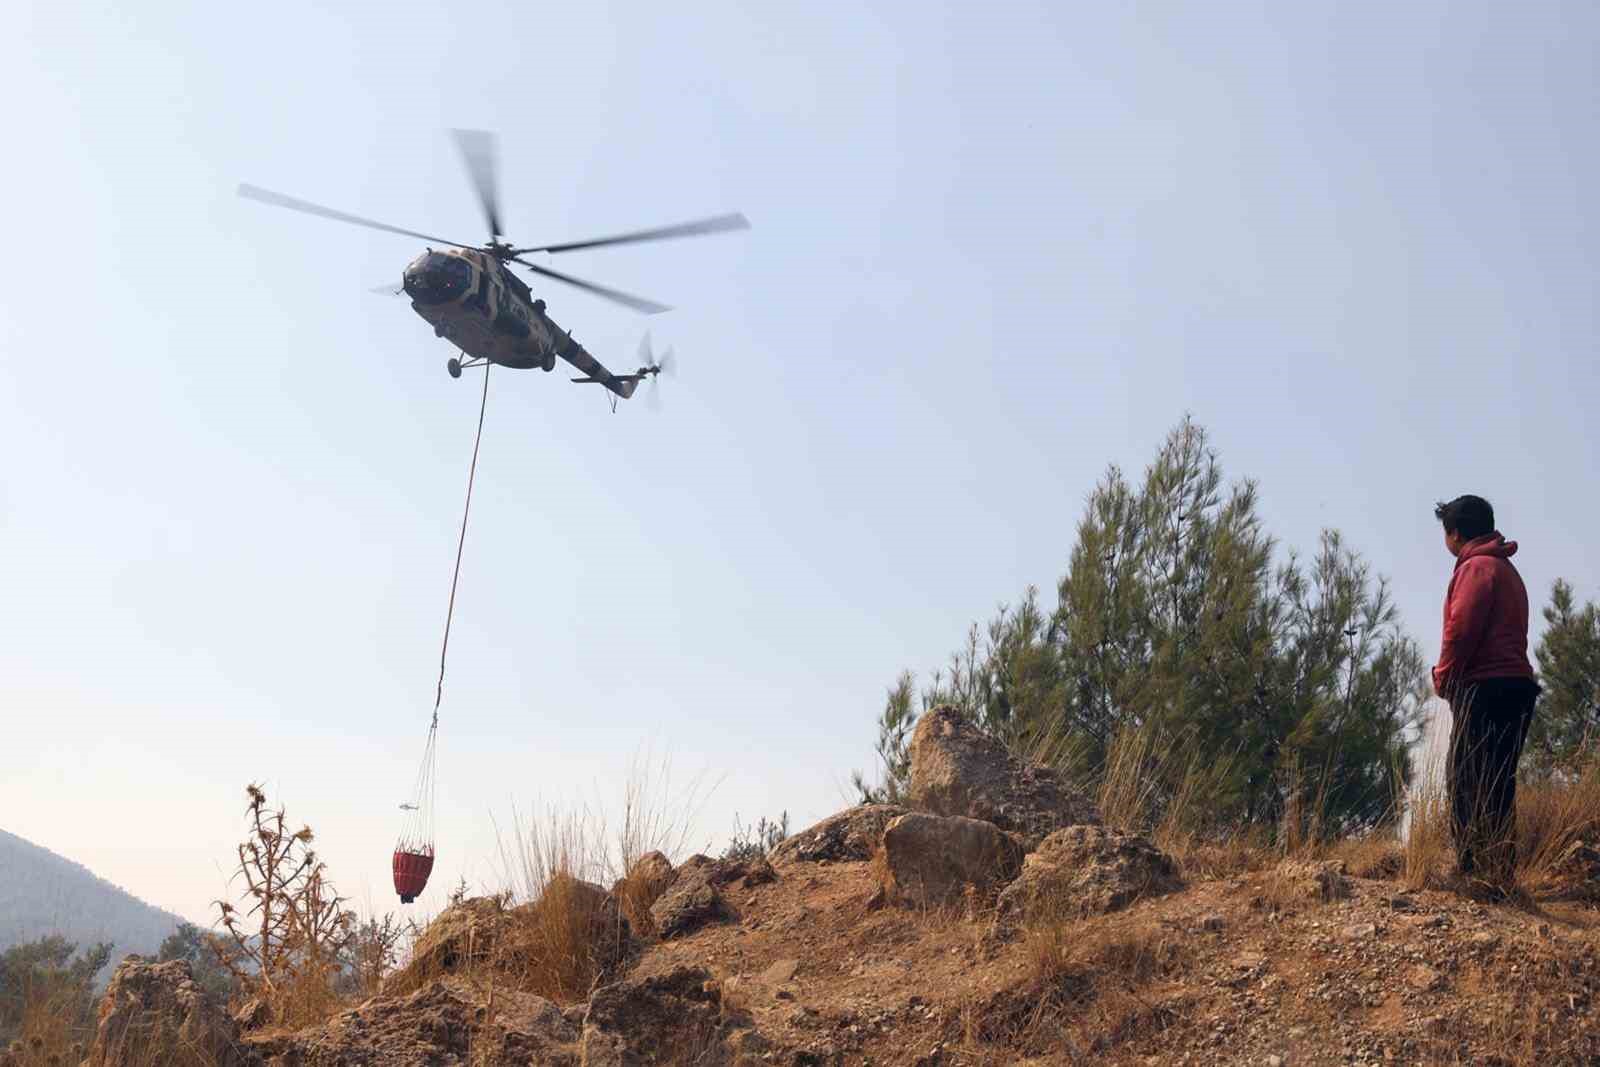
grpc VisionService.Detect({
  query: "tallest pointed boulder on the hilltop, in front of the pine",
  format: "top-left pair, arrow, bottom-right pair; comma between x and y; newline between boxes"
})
910,705 -> 1101,849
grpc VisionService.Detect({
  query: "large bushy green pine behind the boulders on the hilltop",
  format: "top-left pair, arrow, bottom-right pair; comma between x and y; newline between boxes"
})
856,419 -> 1427,835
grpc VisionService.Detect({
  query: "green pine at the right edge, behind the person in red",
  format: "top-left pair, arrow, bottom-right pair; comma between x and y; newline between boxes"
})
1528,579 -> 1600,768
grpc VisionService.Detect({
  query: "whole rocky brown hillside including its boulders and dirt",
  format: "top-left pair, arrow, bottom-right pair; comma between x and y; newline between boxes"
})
56,709 -> 1600,1067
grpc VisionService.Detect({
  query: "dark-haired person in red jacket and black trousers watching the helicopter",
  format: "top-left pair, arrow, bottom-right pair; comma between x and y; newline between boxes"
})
1434,496 -> 1539,889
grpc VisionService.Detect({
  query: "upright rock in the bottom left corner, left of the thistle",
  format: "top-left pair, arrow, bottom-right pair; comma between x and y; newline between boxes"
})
83,955 -> 250,1067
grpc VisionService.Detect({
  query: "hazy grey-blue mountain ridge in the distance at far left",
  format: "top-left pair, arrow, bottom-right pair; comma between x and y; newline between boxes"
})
0,830 -> 182,963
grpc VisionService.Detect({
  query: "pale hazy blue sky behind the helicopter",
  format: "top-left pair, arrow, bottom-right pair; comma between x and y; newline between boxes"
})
0,0 -> 1600,918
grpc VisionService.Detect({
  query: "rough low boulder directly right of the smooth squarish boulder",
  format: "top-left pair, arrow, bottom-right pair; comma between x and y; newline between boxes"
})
1000,825 -> 1182,918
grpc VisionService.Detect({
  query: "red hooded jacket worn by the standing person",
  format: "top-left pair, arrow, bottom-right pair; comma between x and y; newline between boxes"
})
1434,533 -> 1533,696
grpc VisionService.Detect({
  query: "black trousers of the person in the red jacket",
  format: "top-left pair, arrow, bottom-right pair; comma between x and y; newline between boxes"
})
1445,678 -> 1539,883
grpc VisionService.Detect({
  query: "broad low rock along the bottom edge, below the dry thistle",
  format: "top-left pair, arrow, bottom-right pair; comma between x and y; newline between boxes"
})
246,979 -> 581,1067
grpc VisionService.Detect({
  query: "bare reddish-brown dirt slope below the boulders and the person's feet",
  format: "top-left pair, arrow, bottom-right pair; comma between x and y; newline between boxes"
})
632,862 -> 1600,1067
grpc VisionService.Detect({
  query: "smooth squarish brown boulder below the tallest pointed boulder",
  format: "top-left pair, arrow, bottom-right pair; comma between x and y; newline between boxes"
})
883,811 -> 1022,905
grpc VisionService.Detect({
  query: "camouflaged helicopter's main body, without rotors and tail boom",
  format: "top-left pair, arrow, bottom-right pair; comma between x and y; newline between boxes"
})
403,250 -> 573,371
